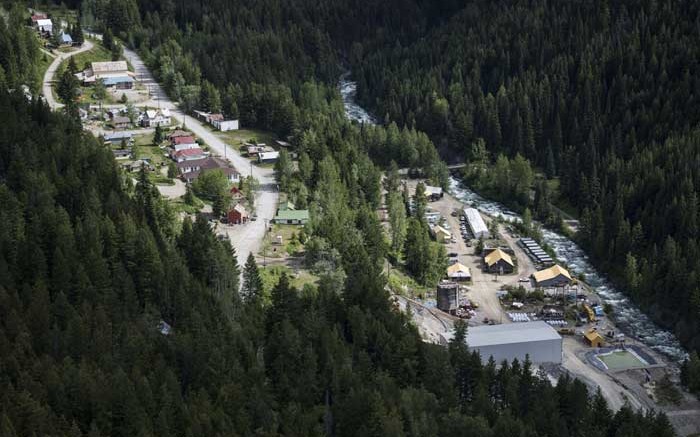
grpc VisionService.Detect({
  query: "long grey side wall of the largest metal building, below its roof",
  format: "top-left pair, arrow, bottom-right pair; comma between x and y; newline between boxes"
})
469,338 -> 562,364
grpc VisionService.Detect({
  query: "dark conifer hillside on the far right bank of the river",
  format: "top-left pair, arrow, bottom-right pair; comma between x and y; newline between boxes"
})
353,0 -> 700,348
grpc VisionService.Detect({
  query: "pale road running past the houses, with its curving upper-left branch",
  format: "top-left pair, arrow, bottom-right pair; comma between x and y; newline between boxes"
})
42,39 -> 279,266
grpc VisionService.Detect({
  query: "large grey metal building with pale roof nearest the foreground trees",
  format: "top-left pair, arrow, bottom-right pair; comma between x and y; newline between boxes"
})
443,321 -> 562,364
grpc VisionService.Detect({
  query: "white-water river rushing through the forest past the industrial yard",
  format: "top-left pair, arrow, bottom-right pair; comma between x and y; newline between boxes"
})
338,74 -> 688,361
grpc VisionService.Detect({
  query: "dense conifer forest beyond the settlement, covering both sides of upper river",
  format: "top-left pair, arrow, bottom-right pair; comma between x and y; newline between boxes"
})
82,0 -> 700,349
